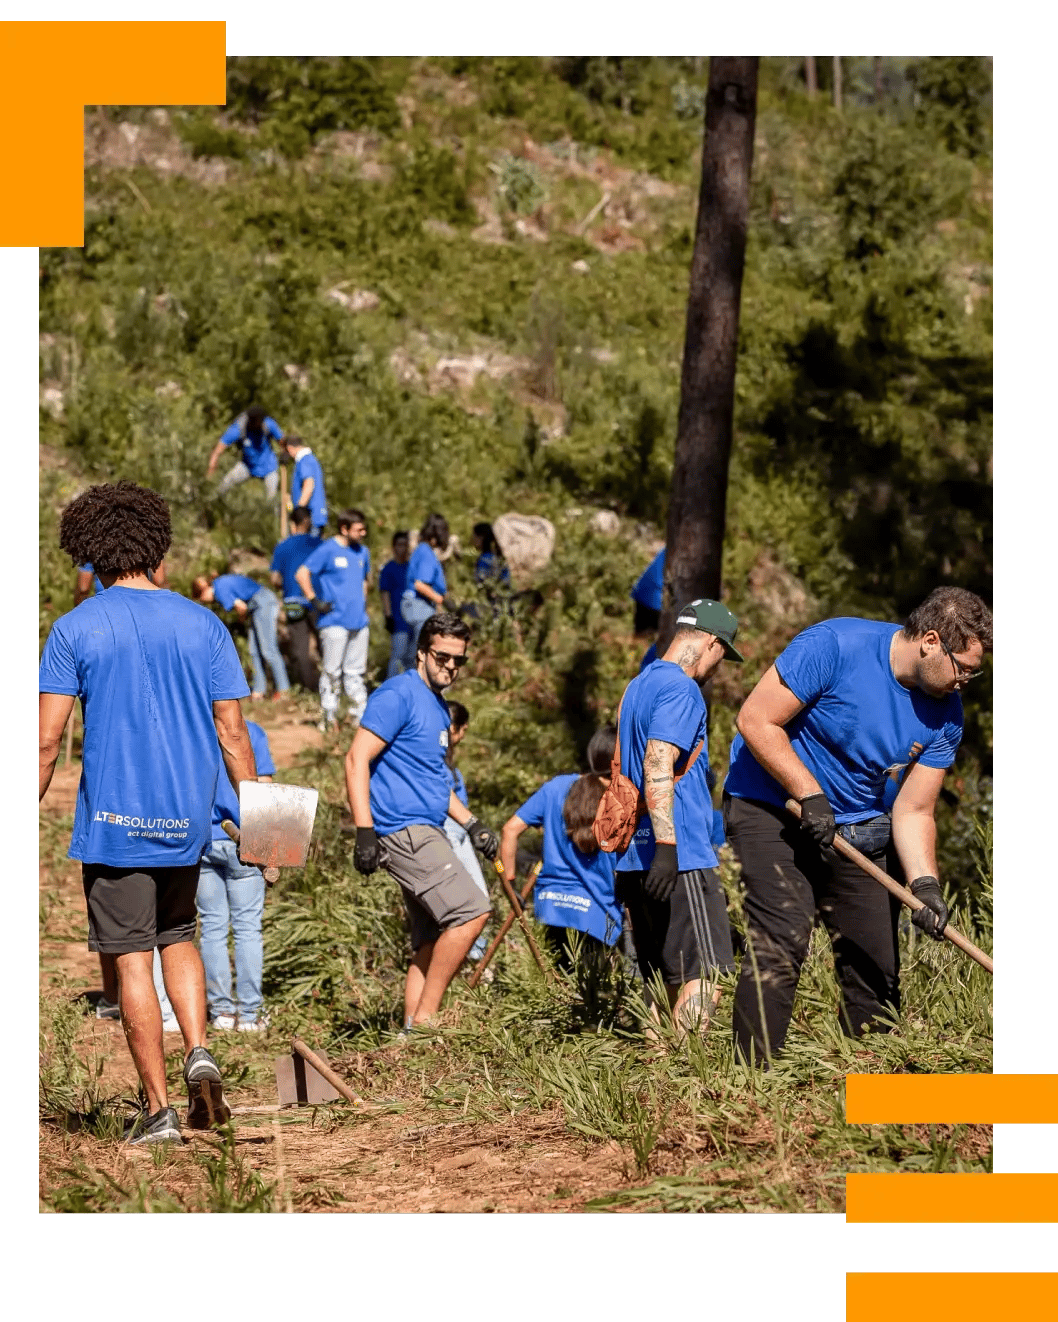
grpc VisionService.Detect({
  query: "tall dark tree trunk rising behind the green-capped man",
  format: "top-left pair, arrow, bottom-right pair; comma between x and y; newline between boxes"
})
659,56 -> 759,649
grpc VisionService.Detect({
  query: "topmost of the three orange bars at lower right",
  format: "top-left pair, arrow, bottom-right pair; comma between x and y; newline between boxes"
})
845,1075 -> 1058,1125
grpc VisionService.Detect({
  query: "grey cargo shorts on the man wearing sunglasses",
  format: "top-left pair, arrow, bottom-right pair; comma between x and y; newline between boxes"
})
381,822 -> 492,951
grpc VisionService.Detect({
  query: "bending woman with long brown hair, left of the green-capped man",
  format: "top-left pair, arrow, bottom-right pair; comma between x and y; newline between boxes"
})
500,726 -> 623,969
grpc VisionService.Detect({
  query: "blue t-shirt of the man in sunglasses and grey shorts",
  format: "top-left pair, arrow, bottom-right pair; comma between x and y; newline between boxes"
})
360,670 -> 451,836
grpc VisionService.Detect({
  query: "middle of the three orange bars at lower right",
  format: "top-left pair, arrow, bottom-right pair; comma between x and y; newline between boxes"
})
845,1171 -> 1058,1224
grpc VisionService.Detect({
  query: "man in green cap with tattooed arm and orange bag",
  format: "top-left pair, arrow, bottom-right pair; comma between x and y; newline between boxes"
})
618,598 -> 742,1031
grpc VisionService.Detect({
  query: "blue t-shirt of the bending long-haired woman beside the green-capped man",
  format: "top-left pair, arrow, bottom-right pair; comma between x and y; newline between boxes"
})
516,775 -> 622,945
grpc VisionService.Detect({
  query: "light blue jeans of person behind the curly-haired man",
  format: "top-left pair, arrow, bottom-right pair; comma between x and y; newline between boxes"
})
196,839 -> 265,1023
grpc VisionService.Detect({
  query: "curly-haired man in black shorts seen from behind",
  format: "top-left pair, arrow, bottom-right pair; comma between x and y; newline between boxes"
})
40,481 -> 257,1144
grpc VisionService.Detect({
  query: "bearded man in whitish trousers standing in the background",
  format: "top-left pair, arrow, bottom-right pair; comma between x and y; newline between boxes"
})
294,509 -> 372,732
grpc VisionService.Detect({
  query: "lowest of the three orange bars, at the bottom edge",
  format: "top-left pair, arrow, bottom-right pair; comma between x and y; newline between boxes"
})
845,1272 -> 1058,1322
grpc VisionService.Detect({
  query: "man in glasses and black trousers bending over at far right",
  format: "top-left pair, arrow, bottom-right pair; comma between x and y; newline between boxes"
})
723,587 -> 992,1063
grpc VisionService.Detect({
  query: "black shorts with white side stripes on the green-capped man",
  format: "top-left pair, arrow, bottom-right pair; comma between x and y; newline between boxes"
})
616,867 -> 735,986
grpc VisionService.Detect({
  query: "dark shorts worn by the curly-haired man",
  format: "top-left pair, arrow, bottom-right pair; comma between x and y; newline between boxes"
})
81,863 -> 198,954
